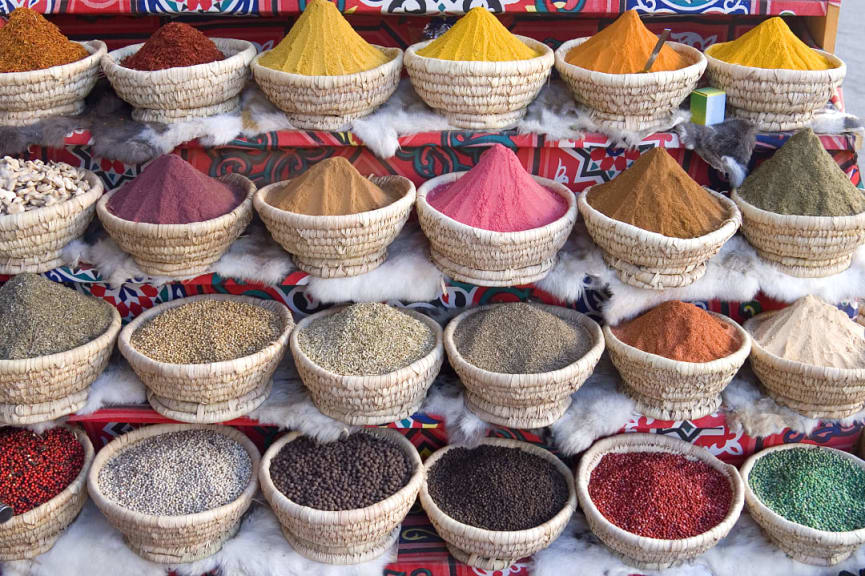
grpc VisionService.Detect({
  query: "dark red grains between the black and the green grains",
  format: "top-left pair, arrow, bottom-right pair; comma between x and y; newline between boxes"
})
589,452 -> 733,540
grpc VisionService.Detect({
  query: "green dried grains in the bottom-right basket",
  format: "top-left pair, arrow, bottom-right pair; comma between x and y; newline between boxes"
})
748,448 -> 865,532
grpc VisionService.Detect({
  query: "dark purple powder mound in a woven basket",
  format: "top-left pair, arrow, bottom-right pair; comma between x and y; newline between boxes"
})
107,154 -> 245,224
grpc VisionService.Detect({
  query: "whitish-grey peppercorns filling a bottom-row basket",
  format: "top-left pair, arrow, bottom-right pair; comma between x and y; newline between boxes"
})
98,429 -> 252,516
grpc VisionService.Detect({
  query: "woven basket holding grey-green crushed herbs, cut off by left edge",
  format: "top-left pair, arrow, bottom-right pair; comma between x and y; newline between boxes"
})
0,302 -> 120,425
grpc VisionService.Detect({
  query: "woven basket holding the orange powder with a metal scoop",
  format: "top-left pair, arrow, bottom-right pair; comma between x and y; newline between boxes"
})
556,38 -> 706,130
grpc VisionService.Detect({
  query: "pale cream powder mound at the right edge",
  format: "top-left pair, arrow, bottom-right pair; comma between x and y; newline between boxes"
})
748,296 -> 865,368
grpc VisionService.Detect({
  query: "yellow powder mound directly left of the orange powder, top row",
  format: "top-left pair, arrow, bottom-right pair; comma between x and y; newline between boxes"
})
417,6 -> 540,62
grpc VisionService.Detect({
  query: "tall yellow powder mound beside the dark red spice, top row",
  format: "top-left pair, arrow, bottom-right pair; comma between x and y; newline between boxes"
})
258,0 -> 390,76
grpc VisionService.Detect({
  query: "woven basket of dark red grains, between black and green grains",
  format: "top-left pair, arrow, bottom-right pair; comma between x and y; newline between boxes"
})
577,434 -> 745,570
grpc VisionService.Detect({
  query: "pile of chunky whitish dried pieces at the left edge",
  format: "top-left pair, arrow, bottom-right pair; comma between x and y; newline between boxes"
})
0,156 -> 90,215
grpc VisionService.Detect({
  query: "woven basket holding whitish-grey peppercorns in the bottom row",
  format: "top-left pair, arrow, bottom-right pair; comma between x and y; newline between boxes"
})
87,424 -> 261,564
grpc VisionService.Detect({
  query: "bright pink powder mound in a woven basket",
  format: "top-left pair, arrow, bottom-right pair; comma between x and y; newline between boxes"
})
427,144 -> 568,232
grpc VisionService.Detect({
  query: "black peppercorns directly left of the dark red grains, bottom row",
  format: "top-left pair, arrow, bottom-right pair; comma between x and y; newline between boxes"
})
427,445 -> 568,531
